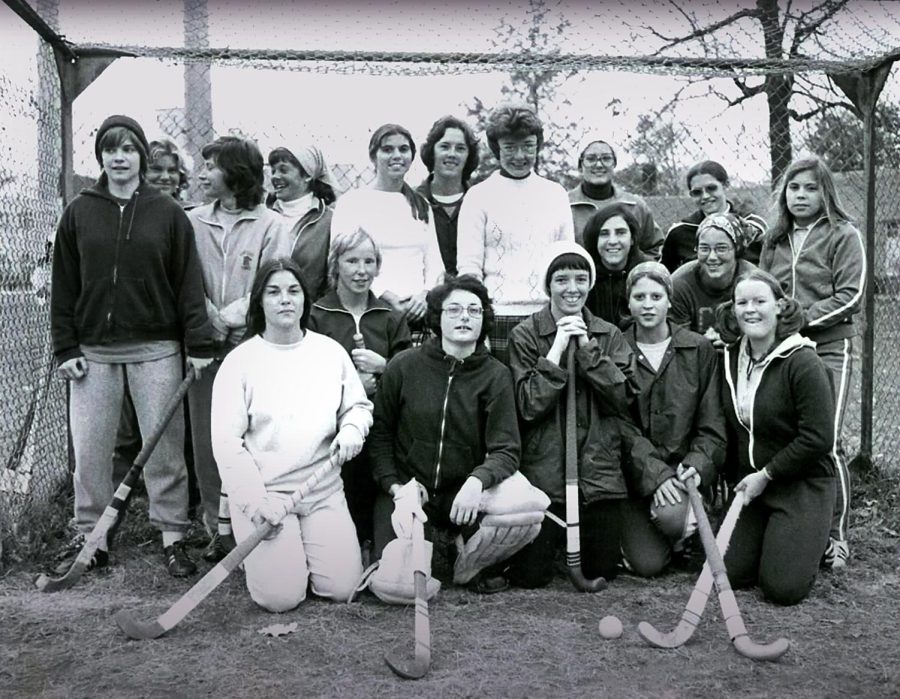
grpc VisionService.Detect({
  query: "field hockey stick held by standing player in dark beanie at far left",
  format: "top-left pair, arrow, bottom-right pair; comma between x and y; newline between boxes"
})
34,366 -> 196,592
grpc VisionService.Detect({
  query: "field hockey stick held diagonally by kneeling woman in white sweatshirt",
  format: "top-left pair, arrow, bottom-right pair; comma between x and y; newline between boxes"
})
114,459 -> 334,641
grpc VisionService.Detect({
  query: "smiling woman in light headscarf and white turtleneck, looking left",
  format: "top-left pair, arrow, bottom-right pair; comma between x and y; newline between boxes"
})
269,146 -> 338,301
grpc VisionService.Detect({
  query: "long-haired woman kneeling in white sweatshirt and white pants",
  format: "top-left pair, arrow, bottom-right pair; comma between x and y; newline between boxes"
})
211,258 -> 372,612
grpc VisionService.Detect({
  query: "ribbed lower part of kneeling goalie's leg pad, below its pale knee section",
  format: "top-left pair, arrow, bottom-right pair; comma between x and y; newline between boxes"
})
453,512 -> 544,585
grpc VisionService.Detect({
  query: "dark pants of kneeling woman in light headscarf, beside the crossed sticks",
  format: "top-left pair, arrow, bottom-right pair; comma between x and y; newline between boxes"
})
622,492 -> 691,578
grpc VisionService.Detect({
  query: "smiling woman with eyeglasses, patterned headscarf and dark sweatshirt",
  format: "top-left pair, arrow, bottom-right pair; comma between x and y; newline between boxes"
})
669,214 -> 756,348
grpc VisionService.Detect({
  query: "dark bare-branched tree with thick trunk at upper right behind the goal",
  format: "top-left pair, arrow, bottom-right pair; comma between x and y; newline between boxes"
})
645,0 -> 861,182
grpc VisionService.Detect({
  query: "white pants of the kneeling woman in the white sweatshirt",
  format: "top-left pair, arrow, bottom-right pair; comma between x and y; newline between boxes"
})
231,490 -> 362,612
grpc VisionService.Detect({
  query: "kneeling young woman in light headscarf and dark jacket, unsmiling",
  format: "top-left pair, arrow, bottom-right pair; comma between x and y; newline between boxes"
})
622,262 -> 725,577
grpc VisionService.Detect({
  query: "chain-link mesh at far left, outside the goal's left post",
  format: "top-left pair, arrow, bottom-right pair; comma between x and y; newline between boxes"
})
0,0 -> 68,556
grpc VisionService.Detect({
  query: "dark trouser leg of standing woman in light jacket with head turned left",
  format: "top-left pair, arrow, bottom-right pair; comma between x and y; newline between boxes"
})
188,361 -> 222,532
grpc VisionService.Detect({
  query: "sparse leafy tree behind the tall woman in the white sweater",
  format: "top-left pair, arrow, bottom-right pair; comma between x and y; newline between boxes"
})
466,0 -> 585,187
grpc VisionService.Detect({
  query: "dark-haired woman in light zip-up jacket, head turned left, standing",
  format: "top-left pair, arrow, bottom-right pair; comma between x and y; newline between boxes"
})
188,136 -> 288,561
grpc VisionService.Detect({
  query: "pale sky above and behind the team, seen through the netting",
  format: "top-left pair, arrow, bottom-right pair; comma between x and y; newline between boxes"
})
0,0 -> 900,191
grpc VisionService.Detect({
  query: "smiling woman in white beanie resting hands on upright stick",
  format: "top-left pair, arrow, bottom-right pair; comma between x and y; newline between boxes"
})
509,241 -> 650,588
